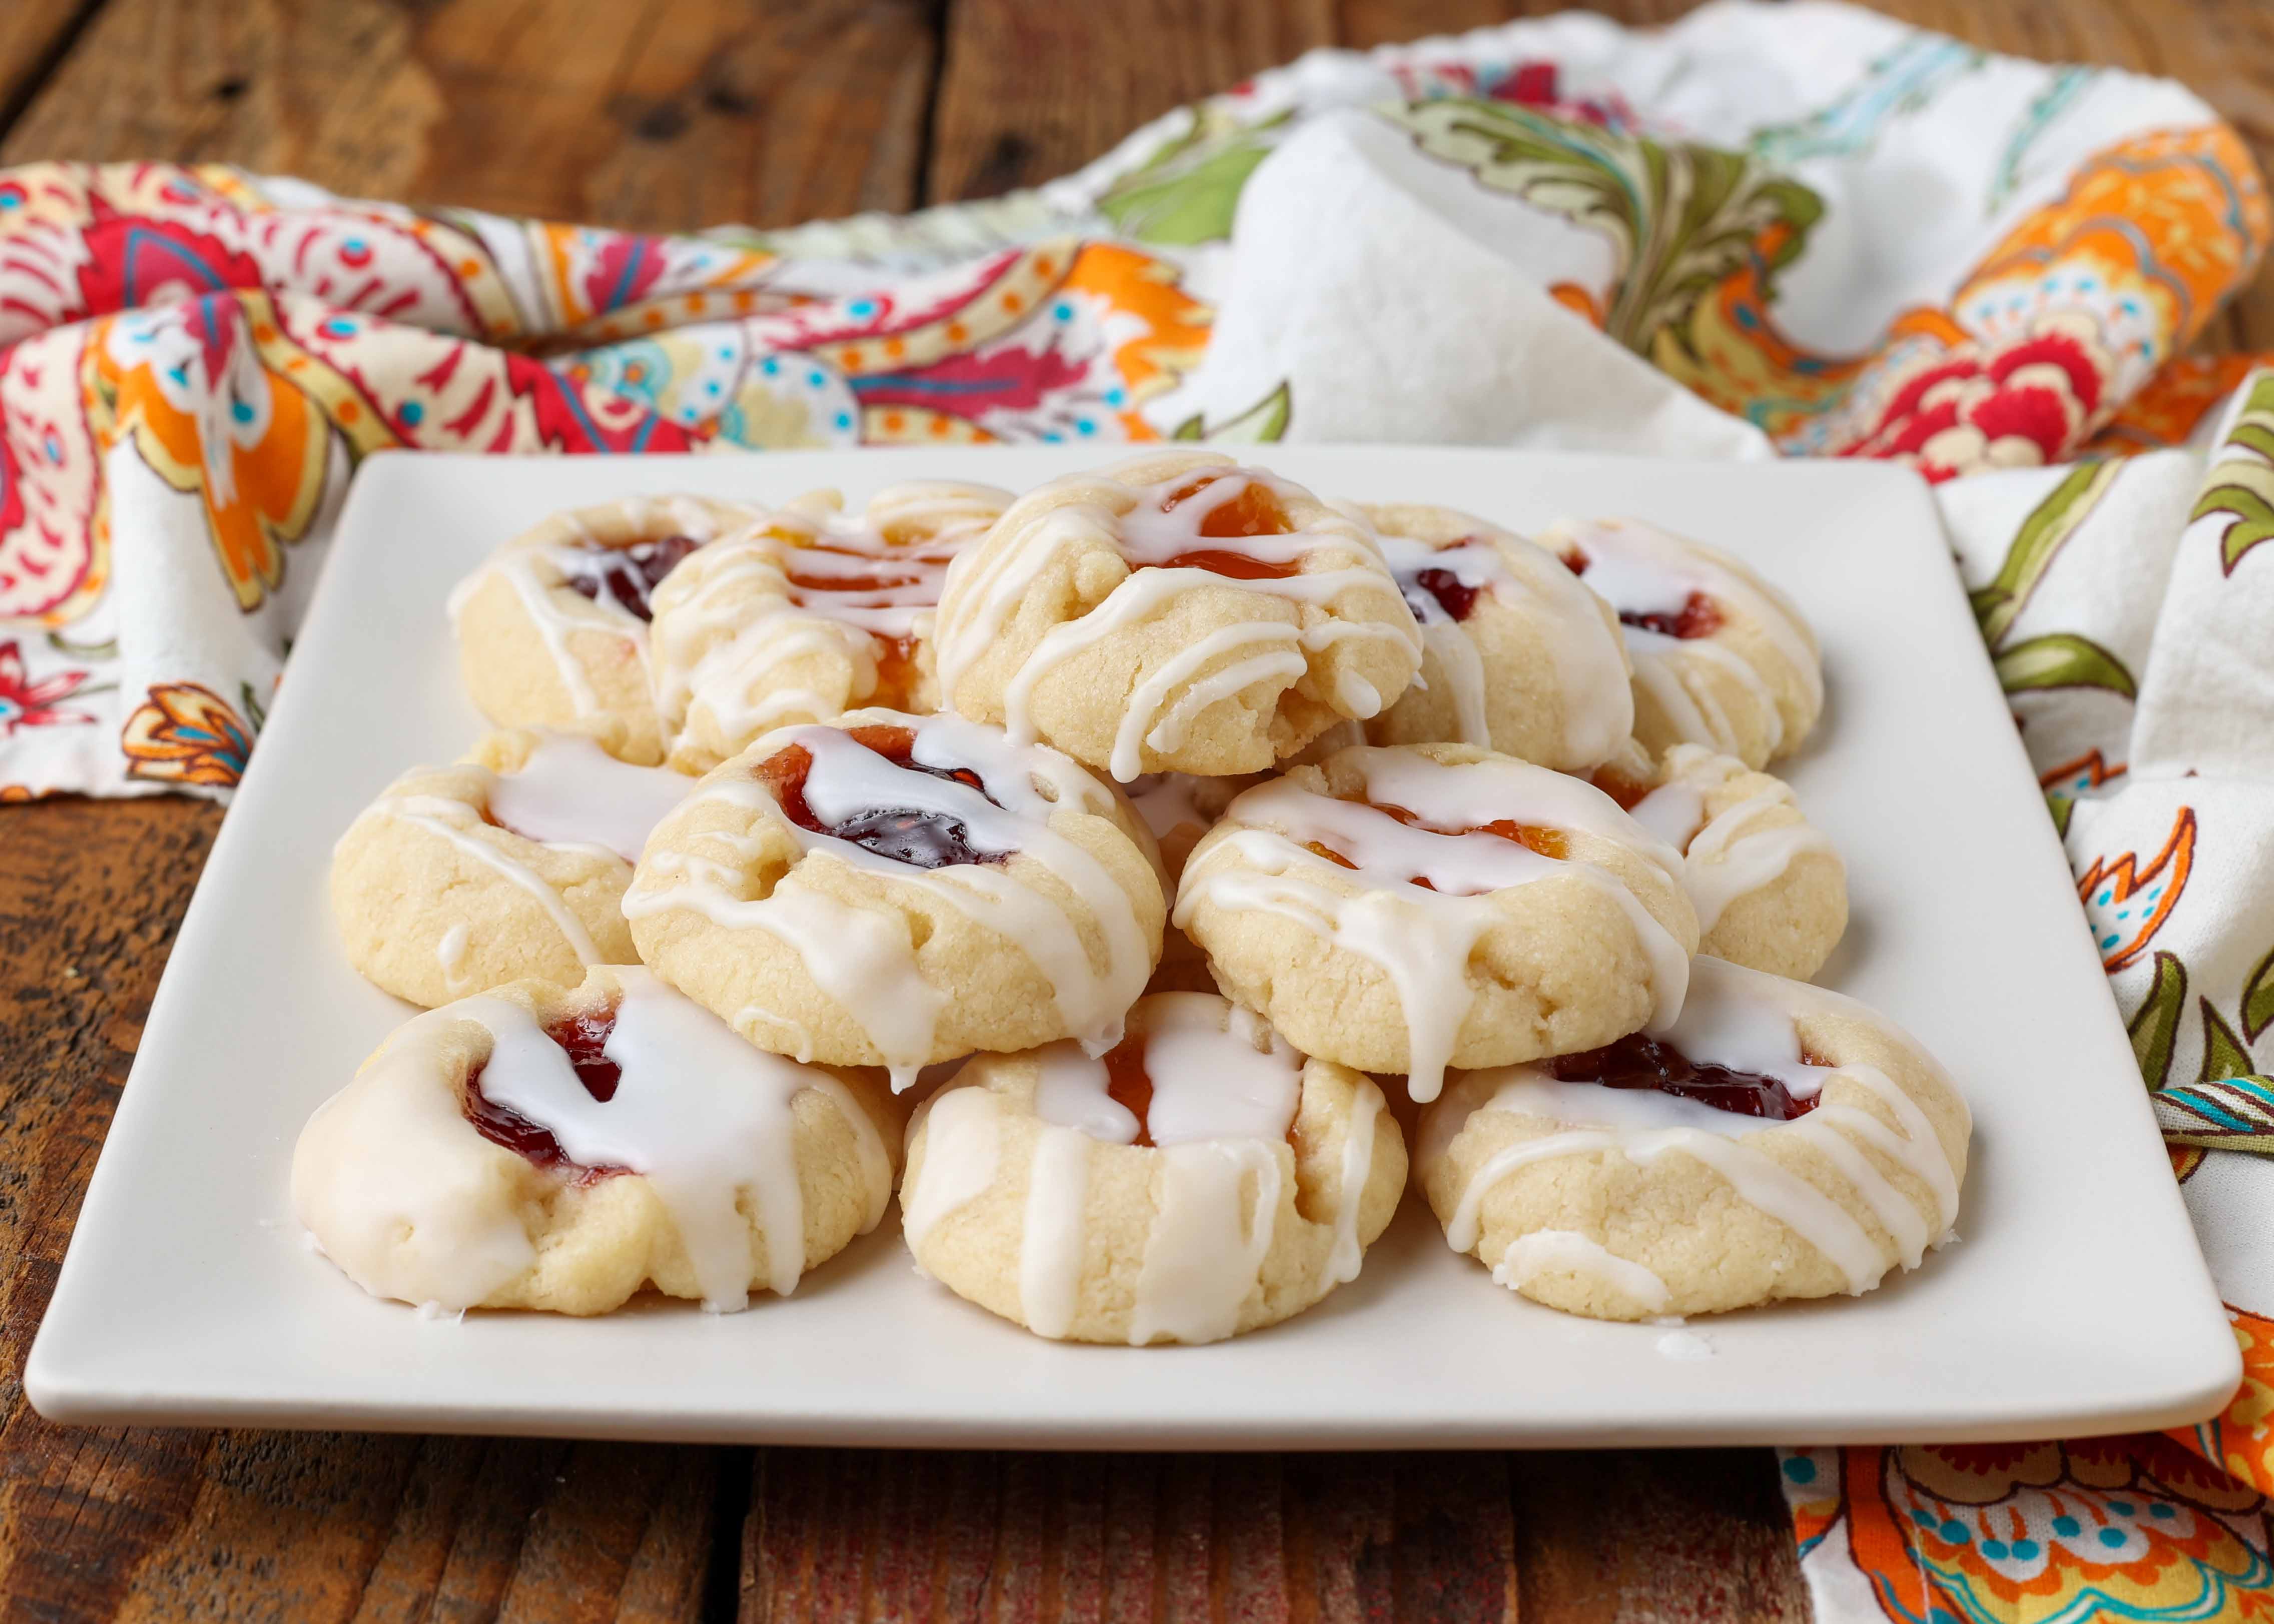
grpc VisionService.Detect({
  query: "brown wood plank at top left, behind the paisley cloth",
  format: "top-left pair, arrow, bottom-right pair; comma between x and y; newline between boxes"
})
0,0 -> 937,230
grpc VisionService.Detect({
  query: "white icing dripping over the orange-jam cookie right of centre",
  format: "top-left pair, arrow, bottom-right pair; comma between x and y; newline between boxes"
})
1174,748 -> 1689,1103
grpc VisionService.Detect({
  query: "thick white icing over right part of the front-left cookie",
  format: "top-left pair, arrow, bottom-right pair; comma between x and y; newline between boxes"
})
432,969 -> 891,1312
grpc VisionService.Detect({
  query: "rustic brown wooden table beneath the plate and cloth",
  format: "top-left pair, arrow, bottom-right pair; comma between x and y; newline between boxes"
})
0,0 -> 2274,1621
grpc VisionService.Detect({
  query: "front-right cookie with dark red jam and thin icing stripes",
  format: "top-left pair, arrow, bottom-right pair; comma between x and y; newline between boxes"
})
1414,958 -> 1972,1319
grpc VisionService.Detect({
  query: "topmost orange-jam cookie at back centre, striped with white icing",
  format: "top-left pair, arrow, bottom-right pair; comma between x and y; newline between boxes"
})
939,450 -> 1421,782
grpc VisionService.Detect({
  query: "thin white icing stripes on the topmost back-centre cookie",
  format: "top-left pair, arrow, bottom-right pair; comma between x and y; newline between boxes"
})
937,464 -> 1421,782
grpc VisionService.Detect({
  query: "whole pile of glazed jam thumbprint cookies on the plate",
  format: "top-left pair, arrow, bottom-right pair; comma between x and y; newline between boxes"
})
293,450 -> 1969,1344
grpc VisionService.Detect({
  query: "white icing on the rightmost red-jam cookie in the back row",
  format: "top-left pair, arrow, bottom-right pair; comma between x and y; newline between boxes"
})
1548,519 -> 1824,755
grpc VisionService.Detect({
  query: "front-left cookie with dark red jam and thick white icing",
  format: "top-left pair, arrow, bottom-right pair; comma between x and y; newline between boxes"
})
291,967 -> 900,1315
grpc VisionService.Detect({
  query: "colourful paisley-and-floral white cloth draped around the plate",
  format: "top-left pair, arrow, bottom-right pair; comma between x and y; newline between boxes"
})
0,0 -> 2274,1624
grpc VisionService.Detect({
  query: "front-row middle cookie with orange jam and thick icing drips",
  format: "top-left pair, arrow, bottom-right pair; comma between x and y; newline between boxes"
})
900,992 -> 1405,1346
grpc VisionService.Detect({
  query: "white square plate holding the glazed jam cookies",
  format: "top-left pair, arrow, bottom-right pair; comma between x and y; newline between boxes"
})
25,446 -> 2240,1449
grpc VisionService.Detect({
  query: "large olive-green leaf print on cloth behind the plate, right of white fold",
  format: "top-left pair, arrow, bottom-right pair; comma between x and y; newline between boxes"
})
1380,98 -> 1824,357
